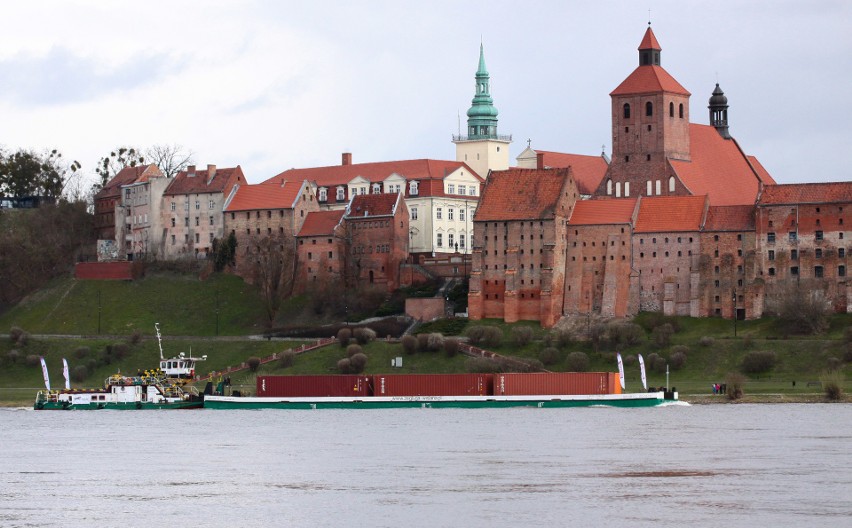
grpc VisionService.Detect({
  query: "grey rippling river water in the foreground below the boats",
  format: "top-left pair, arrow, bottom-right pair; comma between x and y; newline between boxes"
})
0,404 -> 852,528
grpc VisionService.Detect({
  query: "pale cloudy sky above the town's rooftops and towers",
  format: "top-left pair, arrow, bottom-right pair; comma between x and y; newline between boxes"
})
0,0 -> 852,188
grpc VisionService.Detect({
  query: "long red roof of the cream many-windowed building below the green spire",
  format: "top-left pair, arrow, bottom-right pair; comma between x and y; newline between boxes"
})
264,159 -> 484,187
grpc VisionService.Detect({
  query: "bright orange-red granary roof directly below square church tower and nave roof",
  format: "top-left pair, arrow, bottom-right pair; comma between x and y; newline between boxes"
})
633,196 -> 707,233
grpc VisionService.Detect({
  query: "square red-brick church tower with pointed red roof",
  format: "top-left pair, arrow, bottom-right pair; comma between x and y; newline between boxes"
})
604,27 -> 690,196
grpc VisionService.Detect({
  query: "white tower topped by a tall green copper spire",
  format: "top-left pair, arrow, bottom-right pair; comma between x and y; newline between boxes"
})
453,44 -> 512,178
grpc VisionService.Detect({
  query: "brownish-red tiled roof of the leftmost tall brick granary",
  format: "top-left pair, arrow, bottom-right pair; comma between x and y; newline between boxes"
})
474,168 -> 571,221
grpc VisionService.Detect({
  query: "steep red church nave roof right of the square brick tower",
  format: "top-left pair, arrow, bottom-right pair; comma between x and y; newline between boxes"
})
669,123 -> 759,205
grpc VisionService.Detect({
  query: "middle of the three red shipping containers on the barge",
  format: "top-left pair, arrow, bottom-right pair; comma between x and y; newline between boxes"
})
373,374 -> 492,396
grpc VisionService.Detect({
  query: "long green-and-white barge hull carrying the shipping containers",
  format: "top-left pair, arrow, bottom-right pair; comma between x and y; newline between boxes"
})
204,392 -> 678,410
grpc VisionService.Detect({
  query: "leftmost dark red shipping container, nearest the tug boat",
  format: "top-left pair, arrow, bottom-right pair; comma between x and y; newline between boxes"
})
256,375 -> 370,398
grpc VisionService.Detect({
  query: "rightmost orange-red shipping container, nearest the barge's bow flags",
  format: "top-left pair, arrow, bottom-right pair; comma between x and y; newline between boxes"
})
494,372 -> 621,396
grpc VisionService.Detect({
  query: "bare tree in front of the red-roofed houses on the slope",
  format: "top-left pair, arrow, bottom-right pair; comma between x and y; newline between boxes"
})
253,235 -> 296,323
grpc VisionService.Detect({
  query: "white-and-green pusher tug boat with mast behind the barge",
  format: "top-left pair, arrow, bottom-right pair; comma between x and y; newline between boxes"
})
34,323 -> 207,410
